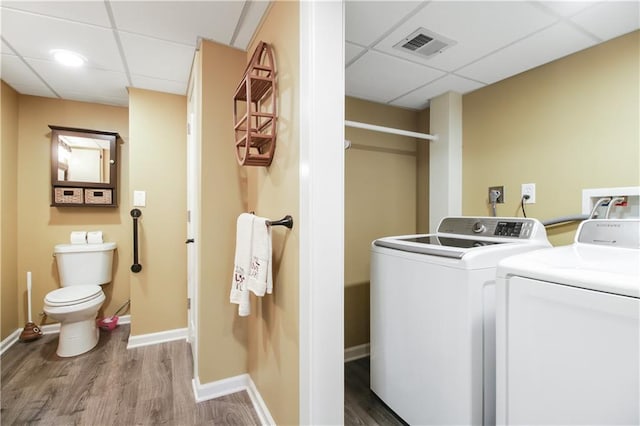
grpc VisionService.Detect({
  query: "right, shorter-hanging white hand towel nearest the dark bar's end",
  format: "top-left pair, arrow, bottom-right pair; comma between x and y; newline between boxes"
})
247,217 -> 273,296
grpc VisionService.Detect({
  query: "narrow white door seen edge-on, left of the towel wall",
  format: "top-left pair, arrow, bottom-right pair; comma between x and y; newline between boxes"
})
187,51 -> 202,378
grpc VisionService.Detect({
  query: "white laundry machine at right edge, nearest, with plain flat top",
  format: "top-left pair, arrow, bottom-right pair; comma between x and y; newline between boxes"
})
496,219 -> 640,425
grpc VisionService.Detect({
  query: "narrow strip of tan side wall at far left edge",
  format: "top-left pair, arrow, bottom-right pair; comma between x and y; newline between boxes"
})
0,82 -> 19,340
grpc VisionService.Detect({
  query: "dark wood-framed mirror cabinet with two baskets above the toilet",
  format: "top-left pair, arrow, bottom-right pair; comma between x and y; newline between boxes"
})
49,125 -> 119,207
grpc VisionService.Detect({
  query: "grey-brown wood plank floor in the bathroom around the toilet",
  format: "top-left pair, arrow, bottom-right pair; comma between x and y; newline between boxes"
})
0,325 -> 259,425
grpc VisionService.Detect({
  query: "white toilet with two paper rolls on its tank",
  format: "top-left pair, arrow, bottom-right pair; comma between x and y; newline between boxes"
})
44,243 -> 116,357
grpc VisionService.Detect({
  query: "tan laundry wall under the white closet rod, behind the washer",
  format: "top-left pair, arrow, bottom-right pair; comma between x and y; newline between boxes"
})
344,97 -> 420,347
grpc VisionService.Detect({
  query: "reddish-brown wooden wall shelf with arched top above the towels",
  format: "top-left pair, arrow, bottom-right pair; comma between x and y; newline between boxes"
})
233,41 -> 278,166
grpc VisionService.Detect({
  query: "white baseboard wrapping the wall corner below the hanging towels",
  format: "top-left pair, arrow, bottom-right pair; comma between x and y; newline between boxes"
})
192,374 -> 276,425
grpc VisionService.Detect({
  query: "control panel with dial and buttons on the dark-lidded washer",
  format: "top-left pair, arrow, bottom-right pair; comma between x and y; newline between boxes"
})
438,216 -> 544,240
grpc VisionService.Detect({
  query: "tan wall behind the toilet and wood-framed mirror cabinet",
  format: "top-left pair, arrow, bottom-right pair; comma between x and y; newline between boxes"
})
15,95 -> 131,324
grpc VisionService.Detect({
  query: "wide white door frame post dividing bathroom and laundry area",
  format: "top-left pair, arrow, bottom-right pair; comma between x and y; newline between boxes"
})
297,1 -> 344,425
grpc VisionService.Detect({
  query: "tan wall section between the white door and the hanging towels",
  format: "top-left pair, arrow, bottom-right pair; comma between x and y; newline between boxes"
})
196,41 -> 248,383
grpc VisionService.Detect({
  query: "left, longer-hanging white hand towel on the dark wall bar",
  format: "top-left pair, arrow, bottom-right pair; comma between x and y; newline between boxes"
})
230,213 -> 255,317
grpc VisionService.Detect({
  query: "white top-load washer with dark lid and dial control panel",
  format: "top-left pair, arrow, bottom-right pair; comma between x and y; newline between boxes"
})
371,217 -> 550,425
